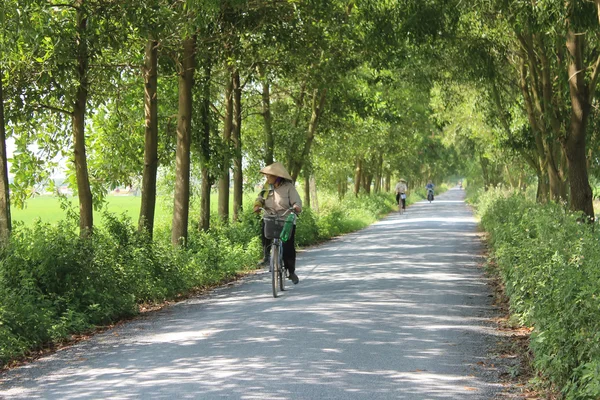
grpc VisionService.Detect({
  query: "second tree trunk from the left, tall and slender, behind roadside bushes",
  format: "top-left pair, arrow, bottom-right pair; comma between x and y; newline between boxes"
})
72,7 -> 94,236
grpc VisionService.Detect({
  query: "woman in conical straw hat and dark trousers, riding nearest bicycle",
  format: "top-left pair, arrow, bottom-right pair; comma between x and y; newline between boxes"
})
254,162 -> 302,284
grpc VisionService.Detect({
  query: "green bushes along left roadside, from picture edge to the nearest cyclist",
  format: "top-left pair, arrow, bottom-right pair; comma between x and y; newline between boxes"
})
0,213 -> 261,363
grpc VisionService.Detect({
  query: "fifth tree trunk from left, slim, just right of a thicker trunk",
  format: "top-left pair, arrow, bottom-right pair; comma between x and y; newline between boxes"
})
198,56 -> 213,231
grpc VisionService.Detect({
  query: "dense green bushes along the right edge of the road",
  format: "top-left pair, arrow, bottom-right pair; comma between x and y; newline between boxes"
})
477,190 -> 600,399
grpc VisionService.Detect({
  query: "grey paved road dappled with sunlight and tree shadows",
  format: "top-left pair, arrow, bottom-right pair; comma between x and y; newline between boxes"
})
0,190 -> 501,400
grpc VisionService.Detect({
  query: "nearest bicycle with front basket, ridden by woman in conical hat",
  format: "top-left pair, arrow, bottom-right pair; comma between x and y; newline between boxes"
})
261,208 -> 297,297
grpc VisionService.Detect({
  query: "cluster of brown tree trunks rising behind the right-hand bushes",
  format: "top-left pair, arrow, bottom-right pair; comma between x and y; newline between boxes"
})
518,27 -> 600,218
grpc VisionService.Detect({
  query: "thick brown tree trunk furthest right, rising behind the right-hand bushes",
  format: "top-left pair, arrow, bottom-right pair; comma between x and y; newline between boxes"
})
564,27 -> 600,220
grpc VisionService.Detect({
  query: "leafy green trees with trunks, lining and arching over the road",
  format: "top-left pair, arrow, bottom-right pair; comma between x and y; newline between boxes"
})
2,0 -> 598,244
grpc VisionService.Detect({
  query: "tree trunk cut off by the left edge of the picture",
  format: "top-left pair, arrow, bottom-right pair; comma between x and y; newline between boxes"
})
0,68 -> 12,245
